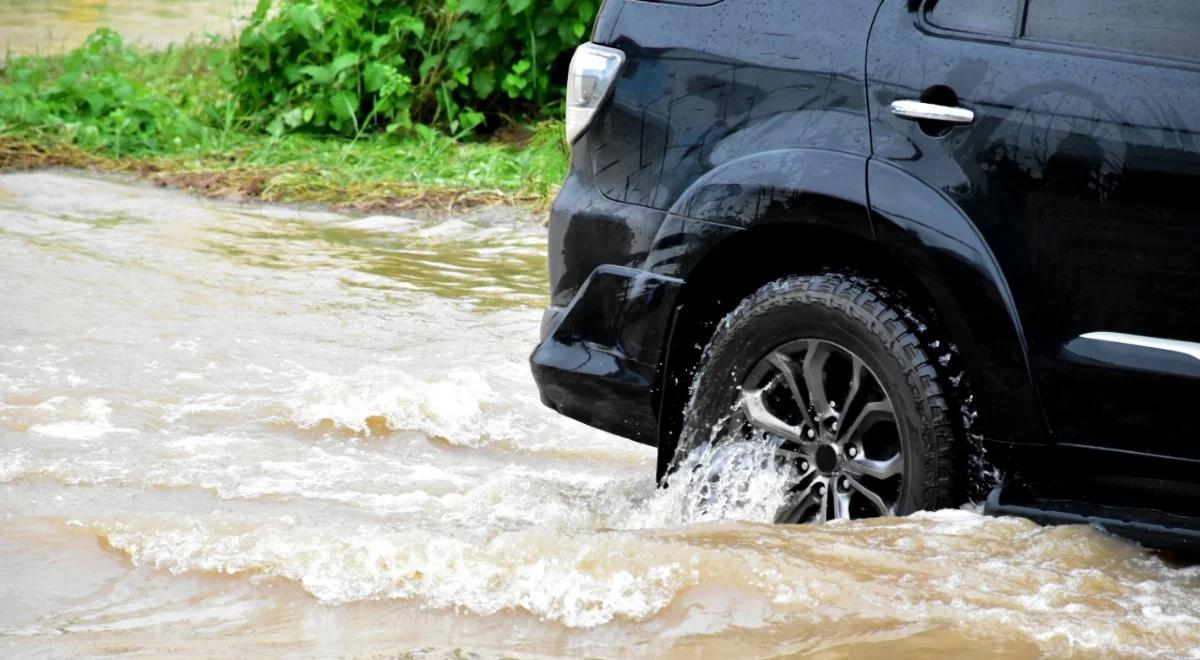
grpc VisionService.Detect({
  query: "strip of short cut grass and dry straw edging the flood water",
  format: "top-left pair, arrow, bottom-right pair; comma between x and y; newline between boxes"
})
0,122 -> 565,212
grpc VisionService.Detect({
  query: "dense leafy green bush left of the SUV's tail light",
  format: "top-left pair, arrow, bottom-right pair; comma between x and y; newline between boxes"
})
238,0 -> 596,137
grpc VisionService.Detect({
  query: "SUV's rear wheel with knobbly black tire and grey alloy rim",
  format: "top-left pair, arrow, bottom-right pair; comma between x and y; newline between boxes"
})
673,272 -> 961,522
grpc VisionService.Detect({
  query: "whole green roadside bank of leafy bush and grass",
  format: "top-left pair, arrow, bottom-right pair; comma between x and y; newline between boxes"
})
0,0 -> 596,210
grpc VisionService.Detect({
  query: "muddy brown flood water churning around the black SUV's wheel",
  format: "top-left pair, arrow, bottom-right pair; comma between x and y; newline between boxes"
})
0,173 -> 1200,659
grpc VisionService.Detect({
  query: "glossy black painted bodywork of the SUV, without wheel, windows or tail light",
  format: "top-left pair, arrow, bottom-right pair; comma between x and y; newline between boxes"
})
533,0 -> 1200,535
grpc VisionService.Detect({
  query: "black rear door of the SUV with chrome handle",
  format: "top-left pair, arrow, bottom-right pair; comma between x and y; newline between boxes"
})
868,0 -> 1200,458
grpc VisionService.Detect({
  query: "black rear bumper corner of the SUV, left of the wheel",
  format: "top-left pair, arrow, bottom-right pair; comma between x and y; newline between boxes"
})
529,265 -> 683,445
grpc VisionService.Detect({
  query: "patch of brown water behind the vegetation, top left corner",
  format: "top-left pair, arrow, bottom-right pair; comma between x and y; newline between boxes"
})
0,0 -> 244,58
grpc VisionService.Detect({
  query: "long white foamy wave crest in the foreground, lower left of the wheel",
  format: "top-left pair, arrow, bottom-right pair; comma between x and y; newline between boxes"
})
92,521 -> 694,626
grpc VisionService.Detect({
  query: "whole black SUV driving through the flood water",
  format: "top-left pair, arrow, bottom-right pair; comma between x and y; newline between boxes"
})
532,0 -> 1200,545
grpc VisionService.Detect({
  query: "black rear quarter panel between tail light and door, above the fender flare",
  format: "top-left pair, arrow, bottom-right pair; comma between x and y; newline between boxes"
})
588,0 -> 877,210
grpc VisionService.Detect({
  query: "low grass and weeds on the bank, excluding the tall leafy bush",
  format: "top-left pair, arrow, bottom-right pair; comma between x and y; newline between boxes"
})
0,32 -> 568,211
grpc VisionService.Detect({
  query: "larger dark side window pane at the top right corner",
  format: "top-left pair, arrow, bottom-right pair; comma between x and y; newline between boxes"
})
1025,0 -> 1200,61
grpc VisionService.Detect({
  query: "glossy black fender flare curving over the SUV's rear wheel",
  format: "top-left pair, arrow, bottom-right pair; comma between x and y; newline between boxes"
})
643,149 -> 1046,456
